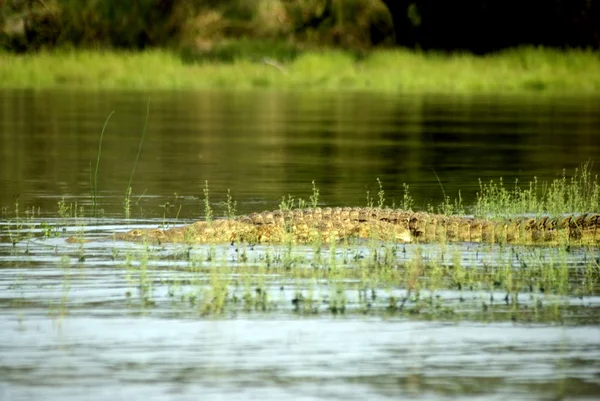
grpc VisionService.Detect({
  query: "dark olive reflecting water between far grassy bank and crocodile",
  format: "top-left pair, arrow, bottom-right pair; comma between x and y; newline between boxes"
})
0,91 -> 600,217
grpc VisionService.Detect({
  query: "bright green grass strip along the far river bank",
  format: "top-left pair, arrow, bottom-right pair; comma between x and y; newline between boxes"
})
0,48 -> 600,95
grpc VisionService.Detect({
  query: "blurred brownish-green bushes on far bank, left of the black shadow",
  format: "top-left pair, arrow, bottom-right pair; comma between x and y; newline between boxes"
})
0,0 -> 393,51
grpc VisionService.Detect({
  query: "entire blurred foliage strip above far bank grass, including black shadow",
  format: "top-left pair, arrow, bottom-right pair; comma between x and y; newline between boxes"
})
0,0 -> 600,56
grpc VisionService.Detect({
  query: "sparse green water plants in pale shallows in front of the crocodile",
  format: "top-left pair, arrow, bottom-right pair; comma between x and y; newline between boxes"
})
85,238 -> 600,322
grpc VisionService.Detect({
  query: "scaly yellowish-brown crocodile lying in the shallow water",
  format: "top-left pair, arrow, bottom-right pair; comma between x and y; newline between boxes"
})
96,207 -> 600,245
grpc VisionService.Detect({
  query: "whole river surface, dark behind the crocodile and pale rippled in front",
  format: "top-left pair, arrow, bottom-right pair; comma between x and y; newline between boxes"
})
0,91 -> 600,400
